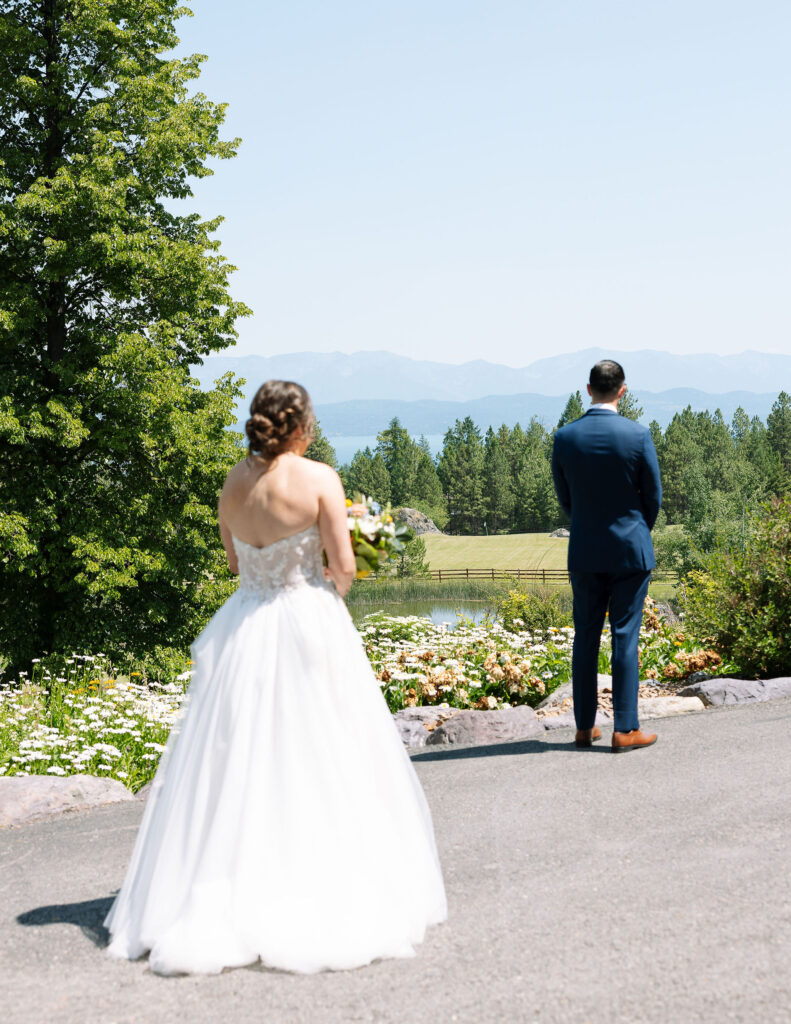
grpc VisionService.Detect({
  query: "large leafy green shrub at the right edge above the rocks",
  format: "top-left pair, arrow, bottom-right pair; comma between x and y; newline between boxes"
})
682,497 -> 791,676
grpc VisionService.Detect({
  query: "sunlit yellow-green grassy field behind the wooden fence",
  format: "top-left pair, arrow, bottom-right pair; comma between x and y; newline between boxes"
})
423,534 -> 569,569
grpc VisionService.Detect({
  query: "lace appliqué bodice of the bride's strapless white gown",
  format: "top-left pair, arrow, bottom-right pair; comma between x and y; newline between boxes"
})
234,524 -> 329,600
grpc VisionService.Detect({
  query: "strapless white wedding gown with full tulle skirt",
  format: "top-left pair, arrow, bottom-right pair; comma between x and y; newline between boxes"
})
106,526 -> 447,974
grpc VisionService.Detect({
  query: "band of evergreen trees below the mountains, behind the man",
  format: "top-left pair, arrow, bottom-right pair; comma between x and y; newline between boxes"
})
309,391 -> 791,570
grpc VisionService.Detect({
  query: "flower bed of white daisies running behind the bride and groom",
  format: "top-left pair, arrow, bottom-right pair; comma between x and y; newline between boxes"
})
0,607 -> 734,792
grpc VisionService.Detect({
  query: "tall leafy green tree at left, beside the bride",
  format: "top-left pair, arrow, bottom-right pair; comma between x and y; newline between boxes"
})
0,0 -> 247,666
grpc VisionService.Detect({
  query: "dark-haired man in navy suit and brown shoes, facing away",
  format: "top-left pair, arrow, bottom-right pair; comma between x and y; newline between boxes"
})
552,359 -> 662,753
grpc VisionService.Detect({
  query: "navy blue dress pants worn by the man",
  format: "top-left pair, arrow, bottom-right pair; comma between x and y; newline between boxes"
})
570,569 -> 651,732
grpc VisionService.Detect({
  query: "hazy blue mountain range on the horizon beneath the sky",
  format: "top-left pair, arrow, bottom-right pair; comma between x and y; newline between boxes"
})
193,348 -> 791,436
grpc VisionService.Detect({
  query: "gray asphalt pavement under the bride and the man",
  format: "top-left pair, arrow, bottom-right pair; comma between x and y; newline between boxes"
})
0,700 -> 791,1024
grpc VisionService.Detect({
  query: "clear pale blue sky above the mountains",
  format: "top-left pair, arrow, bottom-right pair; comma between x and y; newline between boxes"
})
180,0 -> 791,366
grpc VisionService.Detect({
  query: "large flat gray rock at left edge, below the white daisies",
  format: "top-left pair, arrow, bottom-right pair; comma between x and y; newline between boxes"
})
0,775 -> 134,827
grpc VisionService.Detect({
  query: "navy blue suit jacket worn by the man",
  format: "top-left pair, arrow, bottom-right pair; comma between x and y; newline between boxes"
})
552,409 -> 662,572
